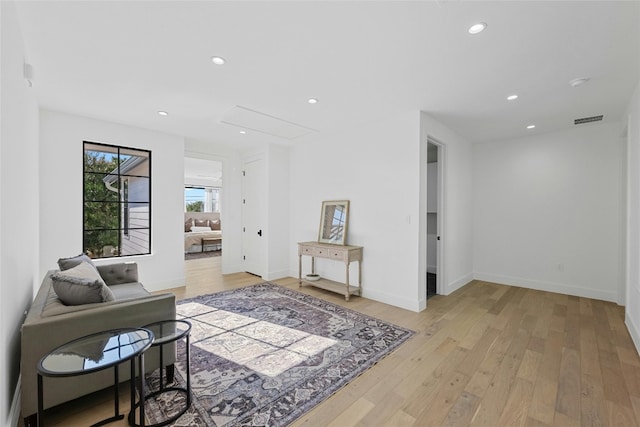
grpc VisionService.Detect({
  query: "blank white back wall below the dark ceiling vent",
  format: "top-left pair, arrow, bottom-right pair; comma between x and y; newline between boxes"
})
473,124 -> 625,302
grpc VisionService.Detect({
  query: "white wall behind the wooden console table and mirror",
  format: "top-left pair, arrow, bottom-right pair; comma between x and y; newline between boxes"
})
288,111 -> 420,311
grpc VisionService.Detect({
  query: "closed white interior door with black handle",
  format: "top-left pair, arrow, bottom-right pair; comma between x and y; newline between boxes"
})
242,158 -> 267,277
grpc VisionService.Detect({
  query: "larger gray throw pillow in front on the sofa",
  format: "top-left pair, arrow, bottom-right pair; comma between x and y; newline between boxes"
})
51,262 -> 115,305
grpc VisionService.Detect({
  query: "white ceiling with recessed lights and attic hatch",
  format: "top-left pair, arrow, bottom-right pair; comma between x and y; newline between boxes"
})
18,0 -> 640,148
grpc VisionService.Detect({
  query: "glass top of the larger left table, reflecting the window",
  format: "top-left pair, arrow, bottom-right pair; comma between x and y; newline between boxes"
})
38,328 -> 154,377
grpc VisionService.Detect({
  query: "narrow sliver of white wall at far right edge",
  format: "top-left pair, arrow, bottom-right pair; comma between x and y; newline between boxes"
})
625,82 -> 640,352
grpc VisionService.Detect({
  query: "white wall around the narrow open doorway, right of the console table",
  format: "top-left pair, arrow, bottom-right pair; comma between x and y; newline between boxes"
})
418,112 -> 473,295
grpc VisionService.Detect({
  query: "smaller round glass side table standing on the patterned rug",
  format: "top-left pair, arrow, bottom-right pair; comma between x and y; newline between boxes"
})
129,320 -> 191,427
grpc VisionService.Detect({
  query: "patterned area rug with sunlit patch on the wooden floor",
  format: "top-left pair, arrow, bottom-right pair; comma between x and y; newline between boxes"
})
145,283 -> 414,427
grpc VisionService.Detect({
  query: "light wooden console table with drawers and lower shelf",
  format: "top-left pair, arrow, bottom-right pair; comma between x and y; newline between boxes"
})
298,242 -> 362,301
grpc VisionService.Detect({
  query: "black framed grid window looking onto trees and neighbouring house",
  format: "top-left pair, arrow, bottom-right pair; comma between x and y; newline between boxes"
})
83,141 -> 151,258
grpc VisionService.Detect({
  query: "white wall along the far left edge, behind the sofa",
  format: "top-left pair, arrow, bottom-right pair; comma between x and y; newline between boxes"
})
0,1 -> 40,426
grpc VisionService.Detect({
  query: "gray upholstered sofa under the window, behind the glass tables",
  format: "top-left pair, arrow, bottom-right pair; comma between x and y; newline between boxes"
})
20,263 -> 176,426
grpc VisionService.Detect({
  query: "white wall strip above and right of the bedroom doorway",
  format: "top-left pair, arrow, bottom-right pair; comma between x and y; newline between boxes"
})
183,138 -> 244,274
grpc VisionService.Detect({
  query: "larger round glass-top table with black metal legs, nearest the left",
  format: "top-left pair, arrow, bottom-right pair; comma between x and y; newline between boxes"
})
37,328 -> 154,427
